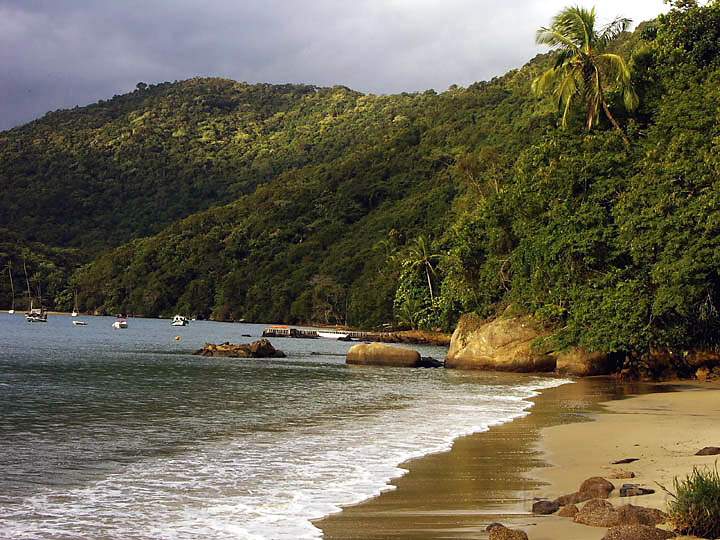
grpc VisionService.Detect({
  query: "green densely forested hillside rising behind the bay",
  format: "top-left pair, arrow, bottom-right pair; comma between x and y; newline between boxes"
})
0,0 -> 720,358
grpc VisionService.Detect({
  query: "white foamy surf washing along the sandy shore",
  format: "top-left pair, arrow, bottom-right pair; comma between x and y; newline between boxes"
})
0,378 -> 568,540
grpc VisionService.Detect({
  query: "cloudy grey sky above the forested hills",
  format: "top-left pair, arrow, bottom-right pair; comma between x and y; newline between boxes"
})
0,0 -> 667,130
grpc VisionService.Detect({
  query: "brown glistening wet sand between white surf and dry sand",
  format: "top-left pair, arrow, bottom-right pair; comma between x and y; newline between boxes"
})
315,379 -> 681,540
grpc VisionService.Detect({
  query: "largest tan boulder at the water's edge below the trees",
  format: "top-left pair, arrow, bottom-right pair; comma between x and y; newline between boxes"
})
445,308 -> 556,372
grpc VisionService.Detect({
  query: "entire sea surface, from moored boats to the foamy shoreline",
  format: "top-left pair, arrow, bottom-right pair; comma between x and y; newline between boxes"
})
0,313 -> 572,540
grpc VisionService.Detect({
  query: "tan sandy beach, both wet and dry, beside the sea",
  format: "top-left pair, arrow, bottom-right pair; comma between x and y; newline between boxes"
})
315,379 -> 720,540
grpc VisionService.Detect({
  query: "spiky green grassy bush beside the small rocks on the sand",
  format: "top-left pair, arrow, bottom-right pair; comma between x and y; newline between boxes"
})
668,464 -> 720,538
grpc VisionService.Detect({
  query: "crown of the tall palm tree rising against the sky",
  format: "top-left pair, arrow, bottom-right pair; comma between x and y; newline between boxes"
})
532,7 -> 638,142
